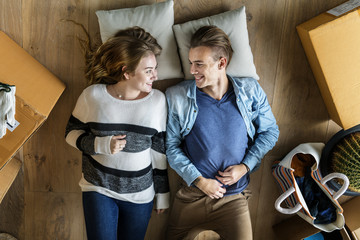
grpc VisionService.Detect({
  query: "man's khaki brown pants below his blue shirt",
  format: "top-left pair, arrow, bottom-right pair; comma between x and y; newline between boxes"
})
167,187 -> 252,240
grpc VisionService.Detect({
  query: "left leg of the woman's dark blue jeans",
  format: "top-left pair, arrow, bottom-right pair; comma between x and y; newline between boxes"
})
83,192 -> 119,240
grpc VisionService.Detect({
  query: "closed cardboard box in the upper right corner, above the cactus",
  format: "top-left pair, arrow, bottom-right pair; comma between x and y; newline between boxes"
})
296,1 -> 360,130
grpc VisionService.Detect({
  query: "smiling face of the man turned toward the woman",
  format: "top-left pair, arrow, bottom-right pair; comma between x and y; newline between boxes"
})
189,46 -> 220,89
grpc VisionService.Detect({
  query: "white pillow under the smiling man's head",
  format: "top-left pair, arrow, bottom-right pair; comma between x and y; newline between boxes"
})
173,7 -> 259,80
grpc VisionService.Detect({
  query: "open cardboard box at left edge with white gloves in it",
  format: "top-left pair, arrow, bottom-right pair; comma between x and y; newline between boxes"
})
0,31 -> 65,169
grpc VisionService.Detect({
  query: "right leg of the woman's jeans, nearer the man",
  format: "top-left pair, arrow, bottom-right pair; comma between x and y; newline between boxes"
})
117,200 -> 153,240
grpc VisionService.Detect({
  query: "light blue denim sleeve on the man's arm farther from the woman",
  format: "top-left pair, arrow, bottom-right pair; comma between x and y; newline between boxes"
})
236,79 -> 279,171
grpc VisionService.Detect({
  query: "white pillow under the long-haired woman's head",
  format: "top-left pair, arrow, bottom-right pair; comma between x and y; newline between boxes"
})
96,0 -> 184,79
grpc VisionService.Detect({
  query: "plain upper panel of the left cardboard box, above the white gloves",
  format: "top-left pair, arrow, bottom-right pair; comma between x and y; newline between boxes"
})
0,31 -> 65,117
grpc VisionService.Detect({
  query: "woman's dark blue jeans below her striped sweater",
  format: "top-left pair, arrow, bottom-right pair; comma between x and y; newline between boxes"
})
83,192 -> 153,240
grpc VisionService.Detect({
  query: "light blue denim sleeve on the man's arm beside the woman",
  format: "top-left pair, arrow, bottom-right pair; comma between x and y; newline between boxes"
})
166,83 -> 201,186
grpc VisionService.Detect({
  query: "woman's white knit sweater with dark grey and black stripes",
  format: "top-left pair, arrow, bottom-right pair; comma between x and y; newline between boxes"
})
66,84 -> 169,209
